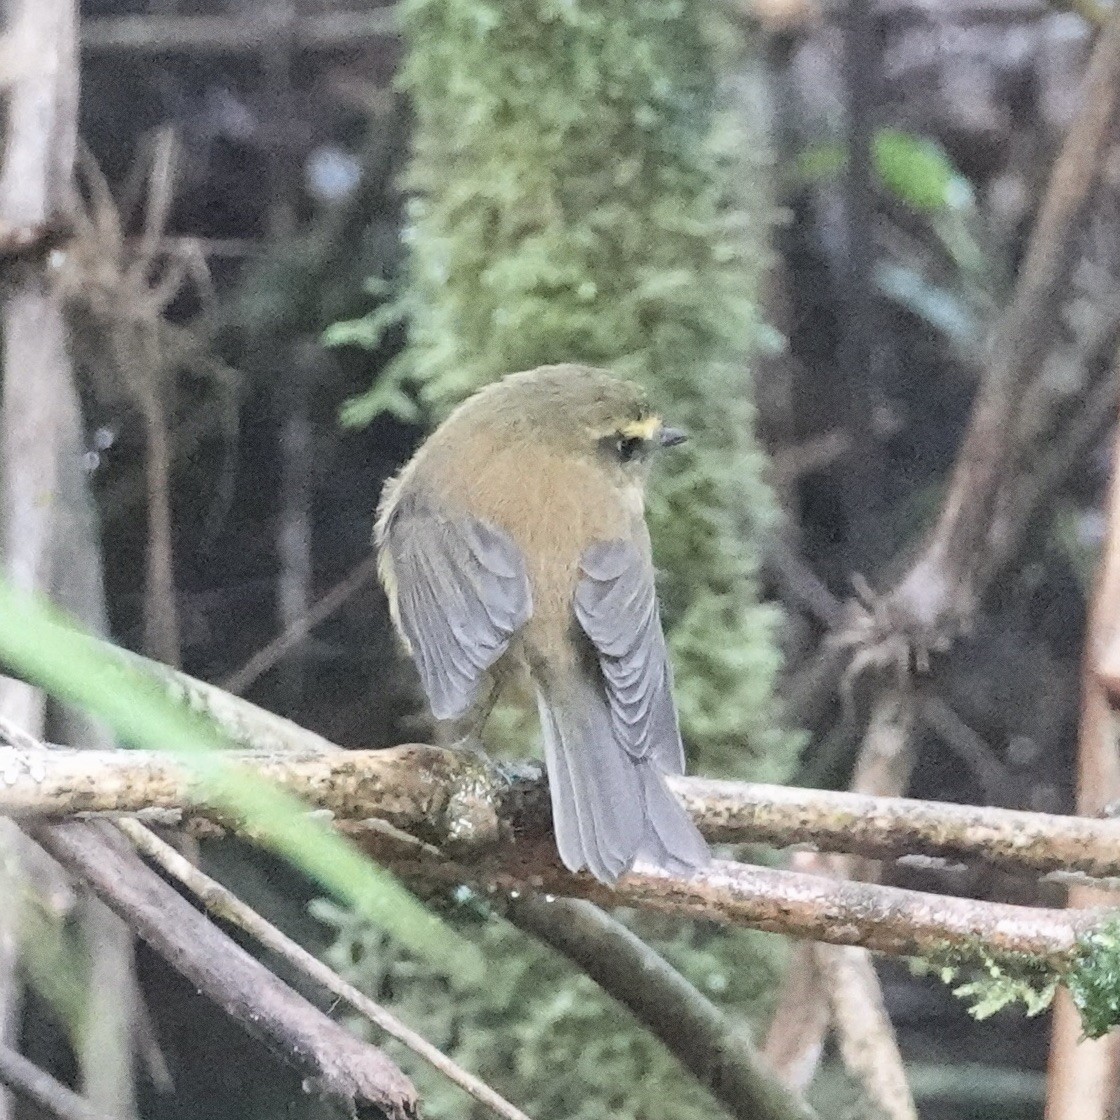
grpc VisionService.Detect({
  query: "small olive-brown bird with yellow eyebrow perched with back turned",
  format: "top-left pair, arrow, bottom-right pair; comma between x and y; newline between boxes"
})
375,365 -> 710,883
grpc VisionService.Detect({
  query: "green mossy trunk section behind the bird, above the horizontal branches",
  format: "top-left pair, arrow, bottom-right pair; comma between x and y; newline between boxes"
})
336,0 -> 799,781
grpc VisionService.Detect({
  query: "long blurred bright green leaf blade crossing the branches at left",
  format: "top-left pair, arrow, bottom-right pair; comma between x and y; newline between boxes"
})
0,580 -> 485,984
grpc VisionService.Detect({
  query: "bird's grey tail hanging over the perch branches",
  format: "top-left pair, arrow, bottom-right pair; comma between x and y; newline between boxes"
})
536,674 -> 711,883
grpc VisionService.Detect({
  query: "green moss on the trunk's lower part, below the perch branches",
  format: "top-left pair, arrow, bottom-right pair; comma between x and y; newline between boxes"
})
315,893 -> 778,1120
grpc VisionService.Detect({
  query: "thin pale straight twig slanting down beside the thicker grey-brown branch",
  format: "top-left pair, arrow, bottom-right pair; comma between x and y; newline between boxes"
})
118,820 -> 529,1120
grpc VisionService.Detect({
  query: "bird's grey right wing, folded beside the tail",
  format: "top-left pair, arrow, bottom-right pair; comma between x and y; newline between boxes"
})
576,540 -> 684,774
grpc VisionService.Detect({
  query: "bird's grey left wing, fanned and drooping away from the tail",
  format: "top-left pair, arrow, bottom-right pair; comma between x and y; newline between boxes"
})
377,493 -> 533,719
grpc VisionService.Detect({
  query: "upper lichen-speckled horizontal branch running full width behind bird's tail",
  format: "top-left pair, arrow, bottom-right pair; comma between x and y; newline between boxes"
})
0,743 -> 1120,878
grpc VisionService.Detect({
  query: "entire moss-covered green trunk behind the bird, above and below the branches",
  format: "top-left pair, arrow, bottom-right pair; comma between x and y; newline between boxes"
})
334,0 -> 799,1120
